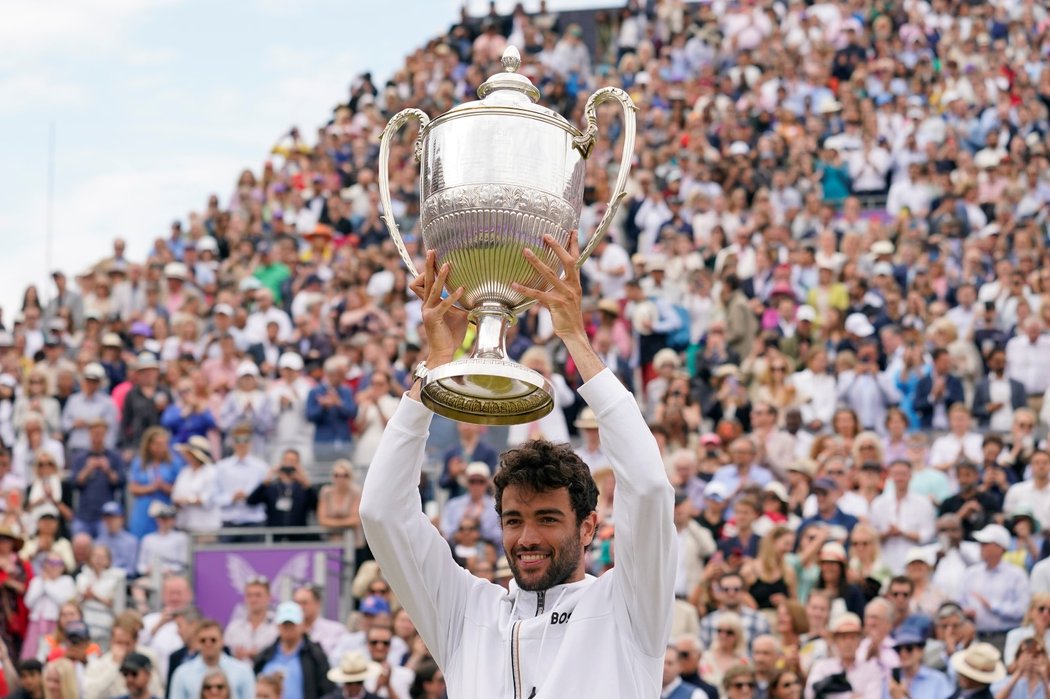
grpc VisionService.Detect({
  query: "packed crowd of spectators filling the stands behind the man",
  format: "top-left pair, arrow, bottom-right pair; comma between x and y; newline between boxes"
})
0,0 -> 1050,699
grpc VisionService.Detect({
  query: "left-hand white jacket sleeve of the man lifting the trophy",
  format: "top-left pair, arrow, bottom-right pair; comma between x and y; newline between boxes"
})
360,398 -> 495,666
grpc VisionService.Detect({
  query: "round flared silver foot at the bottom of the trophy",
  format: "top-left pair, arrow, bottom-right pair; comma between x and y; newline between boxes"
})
422,358 -> 554,425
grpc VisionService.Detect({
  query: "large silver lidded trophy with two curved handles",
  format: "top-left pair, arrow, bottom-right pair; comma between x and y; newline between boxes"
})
379,46 -> 637,425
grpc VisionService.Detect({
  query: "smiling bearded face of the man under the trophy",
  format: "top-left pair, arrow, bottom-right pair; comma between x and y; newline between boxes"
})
502,485 -> 597,591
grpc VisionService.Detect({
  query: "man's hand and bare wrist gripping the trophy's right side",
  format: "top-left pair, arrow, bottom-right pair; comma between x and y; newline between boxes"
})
512,231 -> 605,381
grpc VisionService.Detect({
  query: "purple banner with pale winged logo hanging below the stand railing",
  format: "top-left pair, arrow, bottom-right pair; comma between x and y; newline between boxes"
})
193,544 -> 343,624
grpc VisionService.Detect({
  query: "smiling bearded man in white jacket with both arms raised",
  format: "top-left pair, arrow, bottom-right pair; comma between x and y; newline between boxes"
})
361,235 -> 677,699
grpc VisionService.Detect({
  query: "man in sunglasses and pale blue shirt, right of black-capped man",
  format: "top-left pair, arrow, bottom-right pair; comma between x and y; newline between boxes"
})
168,619 -> 255,699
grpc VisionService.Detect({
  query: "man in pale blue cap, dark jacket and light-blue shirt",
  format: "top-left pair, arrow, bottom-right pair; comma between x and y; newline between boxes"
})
254,601 -> 334,699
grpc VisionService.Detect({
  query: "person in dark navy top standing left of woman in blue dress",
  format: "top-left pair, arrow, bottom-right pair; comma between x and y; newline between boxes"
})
72,418 -> 125,537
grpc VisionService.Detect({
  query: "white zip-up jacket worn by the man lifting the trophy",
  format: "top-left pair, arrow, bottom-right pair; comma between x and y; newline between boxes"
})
360,369 -> 677,699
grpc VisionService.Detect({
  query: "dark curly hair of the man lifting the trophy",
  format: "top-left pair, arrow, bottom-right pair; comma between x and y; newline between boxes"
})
492,440 -> 597,524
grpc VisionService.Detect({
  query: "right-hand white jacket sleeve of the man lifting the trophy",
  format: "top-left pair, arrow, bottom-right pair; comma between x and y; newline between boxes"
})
580,368 -> 678,657
